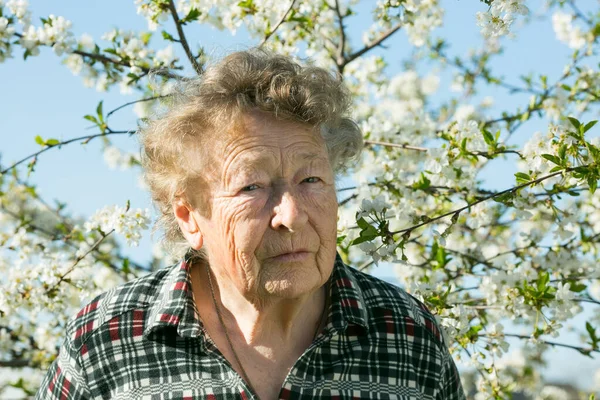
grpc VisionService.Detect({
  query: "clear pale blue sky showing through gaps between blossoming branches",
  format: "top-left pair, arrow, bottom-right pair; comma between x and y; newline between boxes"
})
0,0 -> 600,390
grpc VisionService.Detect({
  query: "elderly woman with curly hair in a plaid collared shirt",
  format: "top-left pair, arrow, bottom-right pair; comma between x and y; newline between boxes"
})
37,50 -> 464,400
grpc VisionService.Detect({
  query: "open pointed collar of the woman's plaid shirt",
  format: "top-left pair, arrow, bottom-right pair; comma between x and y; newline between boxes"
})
144,254 -> 369,337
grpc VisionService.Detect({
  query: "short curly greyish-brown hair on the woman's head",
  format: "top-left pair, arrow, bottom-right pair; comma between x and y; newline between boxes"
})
138,49 -> 363,260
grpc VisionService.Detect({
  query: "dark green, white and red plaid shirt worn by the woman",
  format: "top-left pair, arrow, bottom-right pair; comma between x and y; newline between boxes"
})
36,256 -> 465,400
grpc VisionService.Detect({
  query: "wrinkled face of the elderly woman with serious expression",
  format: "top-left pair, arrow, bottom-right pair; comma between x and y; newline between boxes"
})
189,113 -> 337,300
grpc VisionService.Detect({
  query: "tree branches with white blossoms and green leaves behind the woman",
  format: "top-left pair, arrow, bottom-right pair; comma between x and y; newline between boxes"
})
0,0 -> 600,399
